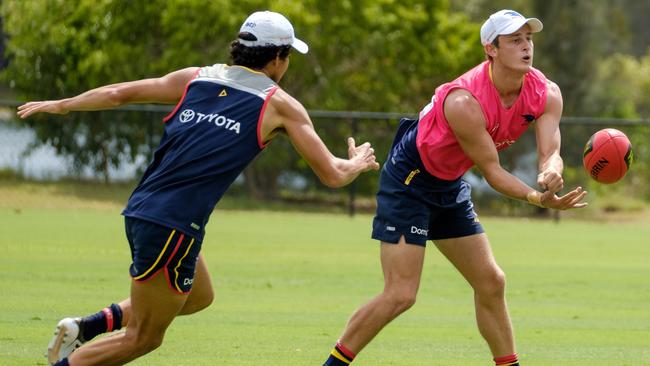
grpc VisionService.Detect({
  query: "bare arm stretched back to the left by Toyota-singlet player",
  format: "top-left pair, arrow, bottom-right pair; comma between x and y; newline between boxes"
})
18,67 -> 198,118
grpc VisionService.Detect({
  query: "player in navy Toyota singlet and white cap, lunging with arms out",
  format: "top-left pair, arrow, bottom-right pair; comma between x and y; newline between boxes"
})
18,11 -> 379,366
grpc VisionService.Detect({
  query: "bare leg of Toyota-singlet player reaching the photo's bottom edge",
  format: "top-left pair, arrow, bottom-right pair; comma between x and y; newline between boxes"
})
69,273 -> 188,366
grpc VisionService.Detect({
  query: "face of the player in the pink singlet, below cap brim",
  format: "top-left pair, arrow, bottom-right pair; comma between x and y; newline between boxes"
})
493,24 -> 534,73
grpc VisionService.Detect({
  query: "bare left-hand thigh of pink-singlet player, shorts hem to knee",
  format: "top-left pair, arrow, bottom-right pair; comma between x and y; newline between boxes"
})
381,236 -> 425,292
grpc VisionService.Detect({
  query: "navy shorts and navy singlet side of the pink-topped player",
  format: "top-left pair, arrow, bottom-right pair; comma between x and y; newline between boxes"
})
372,120 -> 484,246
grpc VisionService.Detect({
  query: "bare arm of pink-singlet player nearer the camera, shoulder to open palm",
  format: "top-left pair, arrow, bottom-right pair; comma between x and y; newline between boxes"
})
444,89 -> 586,210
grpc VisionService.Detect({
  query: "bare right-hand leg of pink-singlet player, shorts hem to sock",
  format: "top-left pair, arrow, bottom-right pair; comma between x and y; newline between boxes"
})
436,234 -> 515,357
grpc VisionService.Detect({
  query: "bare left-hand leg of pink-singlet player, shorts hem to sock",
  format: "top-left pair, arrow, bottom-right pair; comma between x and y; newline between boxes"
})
340,237 -> 424,354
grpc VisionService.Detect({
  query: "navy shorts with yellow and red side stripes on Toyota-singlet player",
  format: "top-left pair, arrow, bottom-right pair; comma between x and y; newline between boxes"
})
124,217 -> 201,294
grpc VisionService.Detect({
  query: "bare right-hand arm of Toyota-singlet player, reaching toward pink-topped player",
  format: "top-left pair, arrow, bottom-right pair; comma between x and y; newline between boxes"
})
262,89 -> 379,188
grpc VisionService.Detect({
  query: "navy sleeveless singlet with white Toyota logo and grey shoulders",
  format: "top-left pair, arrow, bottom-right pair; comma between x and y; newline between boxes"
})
122,64 -> 278,239
